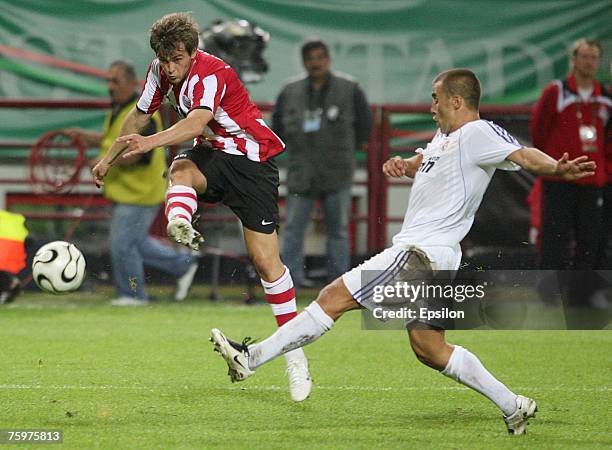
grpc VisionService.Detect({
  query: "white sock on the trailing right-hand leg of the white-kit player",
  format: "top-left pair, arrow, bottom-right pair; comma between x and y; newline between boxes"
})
442,345 -> 516,416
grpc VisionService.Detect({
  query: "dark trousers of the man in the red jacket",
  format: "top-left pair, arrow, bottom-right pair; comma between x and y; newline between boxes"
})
540,181 -> 603,306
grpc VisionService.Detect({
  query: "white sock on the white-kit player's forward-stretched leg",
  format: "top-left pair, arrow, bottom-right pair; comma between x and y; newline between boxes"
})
249,302 -> 334,370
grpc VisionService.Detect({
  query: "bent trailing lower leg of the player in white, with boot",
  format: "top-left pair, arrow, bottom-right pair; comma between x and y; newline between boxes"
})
408,328 -> 537,434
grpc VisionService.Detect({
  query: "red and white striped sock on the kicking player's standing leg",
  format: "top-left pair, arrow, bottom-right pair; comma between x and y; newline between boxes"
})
261,266 -> 306,363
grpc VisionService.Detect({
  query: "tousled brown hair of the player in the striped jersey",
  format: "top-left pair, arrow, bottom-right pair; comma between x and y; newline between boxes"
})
149,12 -> 198,58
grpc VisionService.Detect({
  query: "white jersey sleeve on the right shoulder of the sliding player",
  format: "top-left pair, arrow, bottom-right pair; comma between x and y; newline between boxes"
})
466,120 -> 523,170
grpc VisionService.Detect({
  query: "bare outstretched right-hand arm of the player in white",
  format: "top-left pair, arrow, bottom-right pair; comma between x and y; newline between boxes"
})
506,147 -> 597,181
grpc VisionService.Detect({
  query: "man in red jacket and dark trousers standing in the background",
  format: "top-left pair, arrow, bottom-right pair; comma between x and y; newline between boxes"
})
531,39 -> 612,305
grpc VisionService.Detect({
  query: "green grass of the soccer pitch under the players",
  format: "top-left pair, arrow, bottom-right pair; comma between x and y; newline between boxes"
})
0,290 -> 612,449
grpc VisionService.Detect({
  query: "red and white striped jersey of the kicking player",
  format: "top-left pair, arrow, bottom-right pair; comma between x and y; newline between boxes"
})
136,50 -> 285,161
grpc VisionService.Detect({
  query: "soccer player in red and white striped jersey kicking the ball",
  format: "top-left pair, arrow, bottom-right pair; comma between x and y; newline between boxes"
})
92,13 -> 312,401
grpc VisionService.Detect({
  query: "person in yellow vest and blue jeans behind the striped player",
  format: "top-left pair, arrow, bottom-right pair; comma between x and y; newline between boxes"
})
65,61 -> 198,306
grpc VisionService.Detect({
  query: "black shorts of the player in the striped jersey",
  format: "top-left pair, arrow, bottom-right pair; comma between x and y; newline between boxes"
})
174,145 -> 279,234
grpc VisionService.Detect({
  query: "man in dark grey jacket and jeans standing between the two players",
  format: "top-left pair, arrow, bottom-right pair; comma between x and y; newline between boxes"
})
272,40 -> 372,284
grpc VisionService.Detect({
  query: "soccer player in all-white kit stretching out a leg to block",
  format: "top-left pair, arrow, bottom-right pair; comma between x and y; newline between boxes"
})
211,69 -> 595,434
